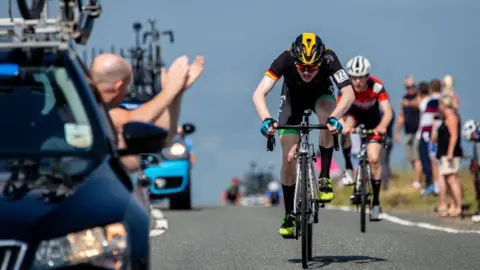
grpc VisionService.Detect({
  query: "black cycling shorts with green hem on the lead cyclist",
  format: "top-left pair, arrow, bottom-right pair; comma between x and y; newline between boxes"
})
277,84 -> 335,135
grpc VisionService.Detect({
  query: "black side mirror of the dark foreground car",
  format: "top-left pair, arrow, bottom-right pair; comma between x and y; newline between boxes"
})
119,122 -> 168,156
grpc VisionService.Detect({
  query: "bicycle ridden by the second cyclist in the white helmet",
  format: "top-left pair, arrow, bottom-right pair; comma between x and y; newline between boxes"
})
351,124 -> 387,233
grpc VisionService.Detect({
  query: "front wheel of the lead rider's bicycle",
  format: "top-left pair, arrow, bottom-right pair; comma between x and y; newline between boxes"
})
297,155 -> 312,269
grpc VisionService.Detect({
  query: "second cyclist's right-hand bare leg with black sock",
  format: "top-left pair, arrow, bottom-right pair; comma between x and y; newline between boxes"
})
367,141 -> 382,206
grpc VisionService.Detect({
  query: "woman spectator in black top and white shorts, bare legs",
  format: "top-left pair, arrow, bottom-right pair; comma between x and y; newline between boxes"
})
433,94 -> 463,217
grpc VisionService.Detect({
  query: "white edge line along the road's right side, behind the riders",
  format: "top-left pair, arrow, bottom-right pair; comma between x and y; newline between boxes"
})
325,205 -> 480,234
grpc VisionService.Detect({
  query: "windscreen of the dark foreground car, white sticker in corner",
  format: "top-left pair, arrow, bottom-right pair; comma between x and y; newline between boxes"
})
0,66 -> 94,154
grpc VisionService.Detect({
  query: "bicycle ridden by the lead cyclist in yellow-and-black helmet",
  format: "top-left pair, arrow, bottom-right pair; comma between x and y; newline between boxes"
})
267,110 -> 339,269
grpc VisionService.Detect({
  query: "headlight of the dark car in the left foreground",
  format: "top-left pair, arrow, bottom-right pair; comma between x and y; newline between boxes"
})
33,223 -> 128,269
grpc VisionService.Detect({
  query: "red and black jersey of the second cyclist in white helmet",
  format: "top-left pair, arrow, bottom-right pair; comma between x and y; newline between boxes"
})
337,76 -> 388,111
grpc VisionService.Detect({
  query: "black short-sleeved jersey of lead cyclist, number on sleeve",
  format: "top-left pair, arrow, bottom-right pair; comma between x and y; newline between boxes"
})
265,49 -> 350,91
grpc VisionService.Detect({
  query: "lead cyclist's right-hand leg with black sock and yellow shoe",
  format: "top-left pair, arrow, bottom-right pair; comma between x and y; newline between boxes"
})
315,95 -> 336,202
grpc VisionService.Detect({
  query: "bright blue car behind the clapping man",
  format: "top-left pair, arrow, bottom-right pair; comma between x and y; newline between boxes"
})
142,124 -> 195,210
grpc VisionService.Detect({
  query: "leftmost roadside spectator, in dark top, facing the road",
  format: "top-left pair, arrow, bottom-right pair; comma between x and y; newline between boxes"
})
395,75 -> 422,189
